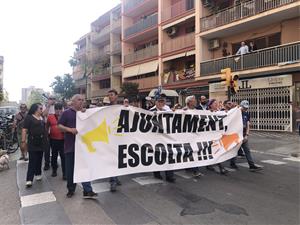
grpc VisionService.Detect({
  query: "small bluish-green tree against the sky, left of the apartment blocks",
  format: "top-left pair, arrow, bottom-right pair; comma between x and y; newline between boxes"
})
50,74 -> 75,101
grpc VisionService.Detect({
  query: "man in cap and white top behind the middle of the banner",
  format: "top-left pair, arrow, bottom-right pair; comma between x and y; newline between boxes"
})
150,94 -> 176,183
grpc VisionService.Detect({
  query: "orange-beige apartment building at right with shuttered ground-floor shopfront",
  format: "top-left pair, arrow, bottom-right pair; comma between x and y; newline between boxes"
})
196,0 -> 300,131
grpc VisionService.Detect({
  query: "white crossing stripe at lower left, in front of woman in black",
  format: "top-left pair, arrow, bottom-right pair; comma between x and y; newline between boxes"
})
21,191 -> 56,207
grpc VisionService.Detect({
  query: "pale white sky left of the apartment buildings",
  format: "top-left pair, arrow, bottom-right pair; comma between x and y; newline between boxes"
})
0,0 -> 120,101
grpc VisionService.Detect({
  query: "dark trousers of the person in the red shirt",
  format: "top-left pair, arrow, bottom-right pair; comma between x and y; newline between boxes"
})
50,139 -> 65,175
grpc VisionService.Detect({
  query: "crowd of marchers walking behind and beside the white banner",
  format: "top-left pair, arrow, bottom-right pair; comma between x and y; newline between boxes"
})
15,89 -> 262,198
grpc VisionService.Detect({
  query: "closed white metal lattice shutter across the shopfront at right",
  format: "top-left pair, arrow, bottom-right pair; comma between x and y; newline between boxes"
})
232,87 -> 292,131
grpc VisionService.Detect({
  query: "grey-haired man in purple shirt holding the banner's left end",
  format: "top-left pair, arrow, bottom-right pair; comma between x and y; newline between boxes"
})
58,94 -> 97,198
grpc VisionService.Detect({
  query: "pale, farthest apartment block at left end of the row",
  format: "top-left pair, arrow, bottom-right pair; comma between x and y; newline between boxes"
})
73,5 -> 122,101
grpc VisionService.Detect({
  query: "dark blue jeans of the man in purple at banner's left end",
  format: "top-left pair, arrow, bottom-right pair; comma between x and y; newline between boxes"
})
65,152 -> 93,192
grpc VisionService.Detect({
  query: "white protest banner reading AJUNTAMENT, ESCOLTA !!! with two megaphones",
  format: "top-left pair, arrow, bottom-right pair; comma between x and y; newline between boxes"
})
74,105 -> 243,182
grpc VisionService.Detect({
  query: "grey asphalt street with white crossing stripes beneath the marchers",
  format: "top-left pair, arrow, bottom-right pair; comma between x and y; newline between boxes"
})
0,133 -> 300,225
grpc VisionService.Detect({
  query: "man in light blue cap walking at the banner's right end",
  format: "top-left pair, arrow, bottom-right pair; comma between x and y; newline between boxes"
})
230,100 -> 262,172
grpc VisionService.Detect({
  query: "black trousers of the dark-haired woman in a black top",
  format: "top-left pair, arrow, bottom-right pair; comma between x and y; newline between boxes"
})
26,151 -> 43,181
